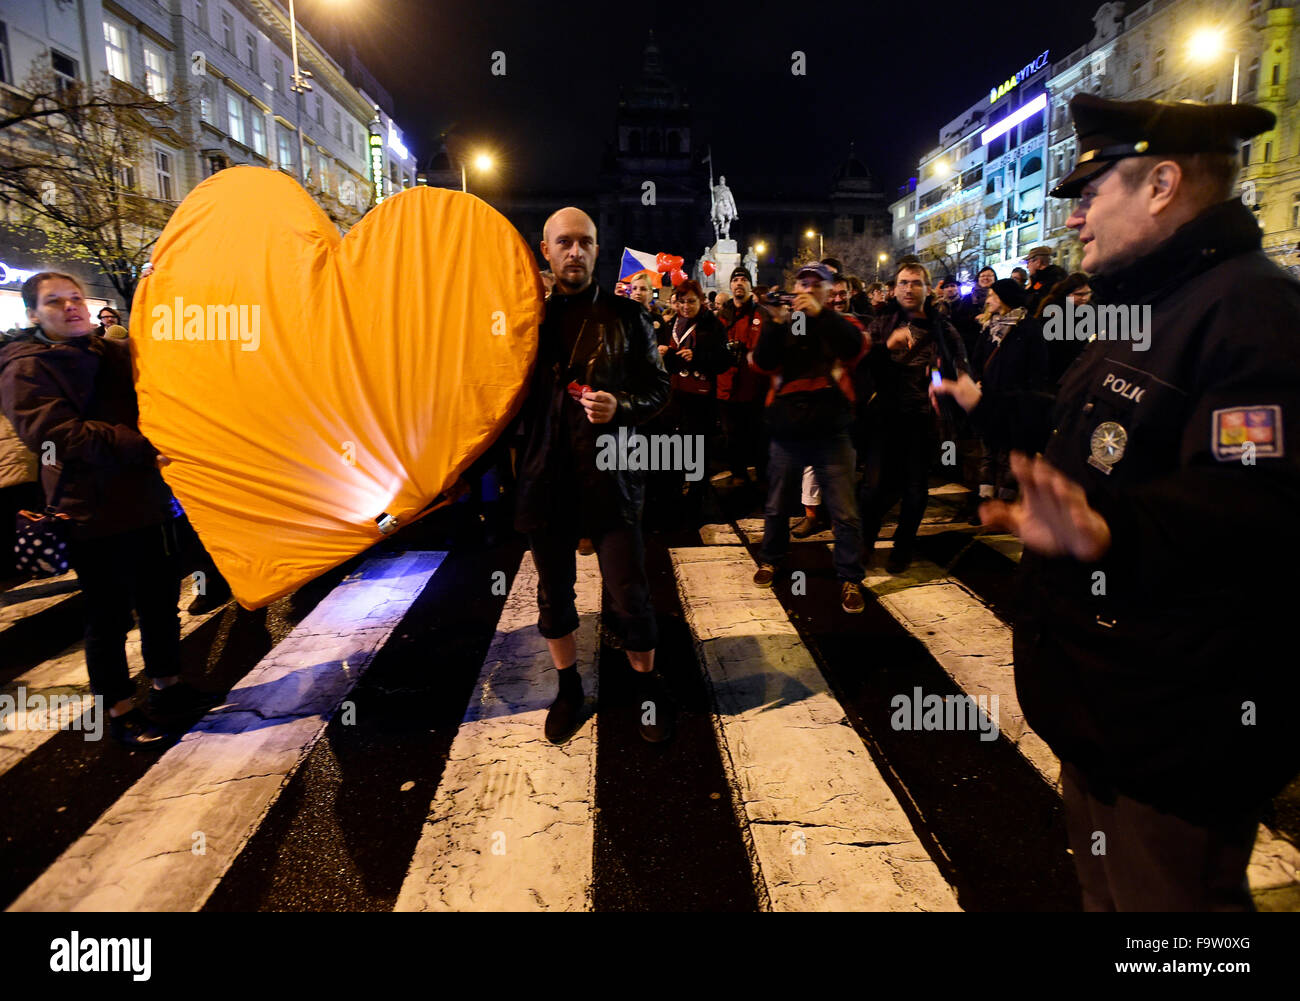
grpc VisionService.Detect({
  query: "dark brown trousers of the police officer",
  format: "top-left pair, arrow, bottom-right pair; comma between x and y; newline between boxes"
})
1061,762 -> 1260,911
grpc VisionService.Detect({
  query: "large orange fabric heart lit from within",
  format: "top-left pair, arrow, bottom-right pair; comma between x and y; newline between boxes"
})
131,166 -> 542,608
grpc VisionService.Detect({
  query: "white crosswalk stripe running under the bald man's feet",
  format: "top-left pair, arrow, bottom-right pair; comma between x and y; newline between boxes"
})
395,553 -> 601,911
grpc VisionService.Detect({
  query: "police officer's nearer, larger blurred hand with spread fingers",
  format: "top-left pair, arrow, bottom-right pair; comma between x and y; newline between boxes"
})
979,452 -> 1110,563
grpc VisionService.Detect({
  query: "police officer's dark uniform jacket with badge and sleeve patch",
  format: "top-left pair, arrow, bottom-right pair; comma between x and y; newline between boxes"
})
1013,200 -> 1300,823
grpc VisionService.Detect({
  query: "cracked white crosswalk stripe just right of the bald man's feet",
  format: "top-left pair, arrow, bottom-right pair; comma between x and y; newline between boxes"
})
670,547 -> 958,911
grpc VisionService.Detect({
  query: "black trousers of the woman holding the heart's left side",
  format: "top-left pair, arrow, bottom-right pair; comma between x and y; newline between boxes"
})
68,524 -> 181,706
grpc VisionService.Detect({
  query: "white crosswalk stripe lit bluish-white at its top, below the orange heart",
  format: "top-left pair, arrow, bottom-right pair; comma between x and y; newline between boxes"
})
10,553 -> 446,911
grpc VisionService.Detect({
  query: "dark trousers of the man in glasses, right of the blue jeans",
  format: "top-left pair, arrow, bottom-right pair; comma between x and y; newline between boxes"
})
858,416 -> 939,554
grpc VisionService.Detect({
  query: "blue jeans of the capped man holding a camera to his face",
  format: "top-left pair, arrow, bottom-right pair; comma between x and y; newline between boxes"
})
758,432 -> 863,584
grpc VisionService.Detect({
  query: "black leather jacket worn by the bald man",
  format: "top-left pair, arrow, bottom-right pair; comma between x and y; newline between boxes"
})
515,283 -> 670,534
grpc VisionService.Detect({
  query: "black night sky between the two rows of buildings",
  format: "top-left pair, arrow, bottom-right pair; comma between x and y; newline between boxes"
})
298,0 -> 1100,200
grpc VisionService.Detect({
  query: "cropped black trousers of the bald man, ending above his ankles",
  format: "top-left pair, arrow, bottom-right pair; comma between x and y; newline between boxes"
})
528,525 -> 659,653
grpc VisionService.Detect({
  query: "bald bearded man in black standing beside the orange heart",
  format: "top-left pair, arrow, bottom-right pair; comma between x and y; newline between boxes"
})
515,208 -> 676,744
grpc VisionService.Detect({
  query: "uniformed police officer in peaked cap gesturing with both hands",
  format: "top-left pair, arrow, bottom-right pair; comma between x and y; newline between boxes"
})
936,95 -> 1300,910
